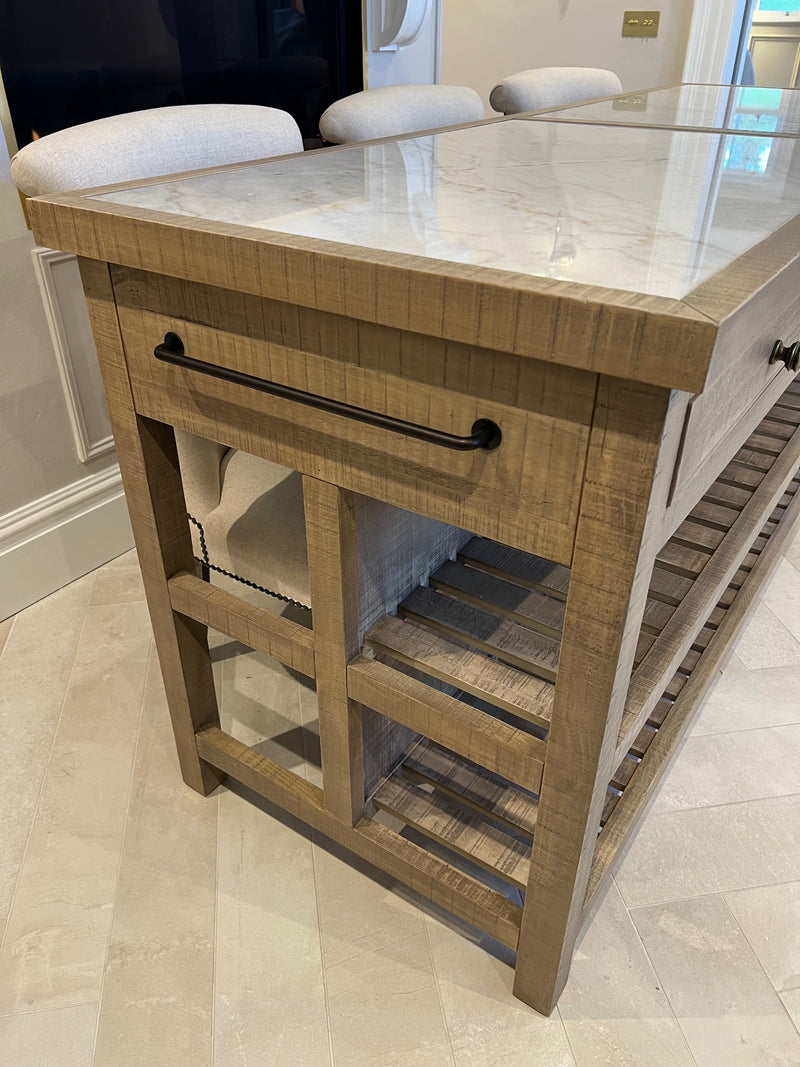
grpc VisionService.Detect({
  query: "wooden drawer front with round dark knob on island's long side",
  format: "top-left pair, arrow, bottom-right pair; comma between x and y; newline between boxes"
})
670,262 -> 800,529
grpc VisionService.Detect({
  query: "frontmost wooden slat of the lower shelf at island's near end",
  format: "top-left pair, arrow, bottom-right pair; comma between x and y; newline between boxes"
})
372,778 -> 530,889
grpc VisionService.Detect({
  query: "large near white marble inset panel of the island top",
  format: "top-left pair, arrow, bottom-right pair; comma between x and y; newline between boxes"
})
90,118 -> 800,299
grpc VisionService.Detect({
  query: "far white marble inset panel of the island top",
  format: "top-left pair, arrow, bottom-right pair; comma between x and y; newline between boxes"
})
530,85 -> 800,137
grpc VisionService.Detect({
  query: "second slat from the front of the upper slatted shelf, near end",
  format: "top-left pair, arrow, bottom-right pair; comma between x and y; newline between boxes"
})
398,588 -> 559,682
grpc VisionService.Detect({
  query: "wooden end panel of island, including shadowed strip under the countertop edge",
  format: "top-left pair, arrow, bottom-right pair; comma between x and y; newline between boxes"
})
115,272 -> 595,564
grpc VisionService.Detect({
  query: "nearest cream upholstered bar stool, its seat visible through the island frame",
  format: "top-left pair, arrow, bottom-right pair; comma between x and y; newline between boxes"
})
11,103 -> 315,602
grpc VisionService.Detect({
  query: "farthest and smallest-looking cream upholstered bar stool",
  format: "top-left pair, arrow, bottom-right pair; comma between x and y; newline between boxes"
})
489,67 -> 622,115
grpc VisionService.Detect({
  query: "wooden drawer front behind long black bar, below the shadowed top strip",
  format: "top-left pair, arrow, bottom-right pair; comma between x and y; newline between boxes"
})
118,306 -> 594,563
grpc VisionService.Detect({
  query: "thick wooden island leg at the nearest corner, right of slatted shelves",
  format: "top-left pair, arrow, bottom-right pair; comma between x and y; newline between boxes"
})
514,378 -> 670,1015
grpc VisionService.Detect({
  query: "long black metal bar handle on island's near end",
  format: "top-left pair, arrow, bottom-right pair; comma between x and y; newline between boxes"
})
153,333 -> 502,452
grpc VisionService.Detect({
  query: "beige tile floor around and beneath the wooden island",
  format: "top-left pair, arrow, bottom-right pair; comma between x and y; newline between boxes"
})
0,538 -> 800,1067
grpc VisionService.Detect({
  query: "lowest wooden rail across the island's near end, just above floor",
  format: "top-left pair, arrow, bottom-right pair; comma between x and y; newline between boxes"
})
190,728 -> 522,949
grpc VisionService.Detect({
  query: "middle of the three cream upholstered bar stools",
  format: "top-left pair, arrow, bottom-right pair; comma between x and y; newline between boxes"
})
319,85 -> 485,144
